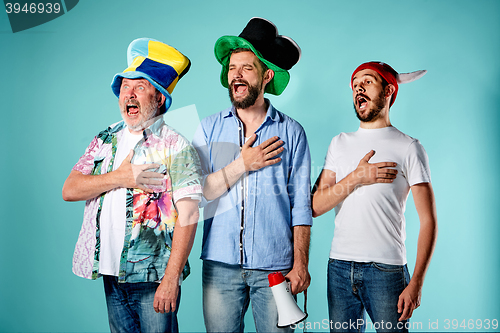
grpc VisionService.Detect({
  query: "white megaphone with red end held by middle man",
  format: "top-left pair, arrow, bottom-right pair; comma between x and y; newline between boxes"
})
267,272 -> 307,328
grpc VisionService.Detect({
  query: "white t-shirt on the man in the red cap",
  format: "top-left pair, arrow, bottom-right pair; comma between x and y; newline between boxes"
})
324,126 -> 431,265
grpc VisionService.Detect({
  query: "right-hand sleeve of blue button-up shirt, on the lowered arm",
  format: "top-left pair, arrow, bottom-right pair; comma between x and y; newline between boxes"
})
288,125 -> 312,227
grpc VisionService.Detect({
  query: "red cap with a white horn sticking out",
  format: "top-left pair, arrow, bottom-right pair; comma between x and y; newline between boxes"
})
351,61 -> 427,106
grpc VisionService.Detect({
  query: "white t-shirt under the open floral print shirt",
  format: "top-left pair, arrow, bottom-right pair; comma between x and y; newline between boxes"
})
99,128 -> 142,276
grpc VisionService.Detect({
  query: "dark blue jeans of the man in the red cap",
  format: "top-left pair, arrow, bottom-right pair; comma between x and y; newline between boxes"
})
327,259 -> 410,332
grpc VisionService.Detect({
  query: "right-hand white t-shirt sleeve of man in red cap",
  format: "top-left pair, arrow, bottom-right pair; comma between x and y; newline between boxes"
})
405,140 -> 431,186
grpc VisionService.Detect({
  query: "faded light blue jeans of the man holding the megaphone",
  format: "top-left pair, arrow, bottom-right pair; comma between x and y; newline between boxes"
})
203,260 -> 293,332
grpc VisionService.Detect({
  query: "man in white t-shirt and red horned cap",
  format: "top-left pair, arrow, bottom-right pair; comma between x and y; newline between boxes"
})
312,62 -> 437,332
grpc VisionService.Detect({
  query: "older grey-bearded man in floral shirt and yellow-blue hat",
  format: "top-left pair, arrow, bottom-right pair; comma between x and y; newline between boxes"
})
63,38 -> 202,332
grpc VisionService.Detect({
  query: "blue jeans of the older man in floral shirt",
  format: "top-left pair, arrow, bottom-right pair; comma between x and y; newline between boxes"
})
103,275 -> 181,333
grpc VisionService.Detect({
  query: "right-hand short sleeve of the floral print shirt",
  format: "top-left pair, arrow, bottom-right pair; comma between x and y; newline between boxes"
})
170,144 -> 203,202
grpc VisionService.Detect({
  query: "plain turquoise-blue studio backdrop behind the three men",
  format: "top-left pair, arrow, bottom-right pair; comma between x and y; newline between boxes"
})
0,0 -> 500,332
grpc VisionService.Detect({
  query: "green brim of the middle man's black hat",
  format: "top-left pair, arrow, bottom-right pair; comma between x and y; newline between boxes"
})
214,36 -> 290,95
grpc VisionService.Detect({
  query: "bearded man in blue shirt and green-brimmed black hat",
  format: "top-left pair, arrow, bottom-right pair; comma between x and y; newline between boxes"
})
193,18 -> 312,332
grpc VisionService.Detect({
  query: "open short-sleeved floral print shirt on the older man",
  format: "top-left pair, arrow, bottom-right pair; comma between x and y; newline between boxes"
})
73,117 -> 202,283
